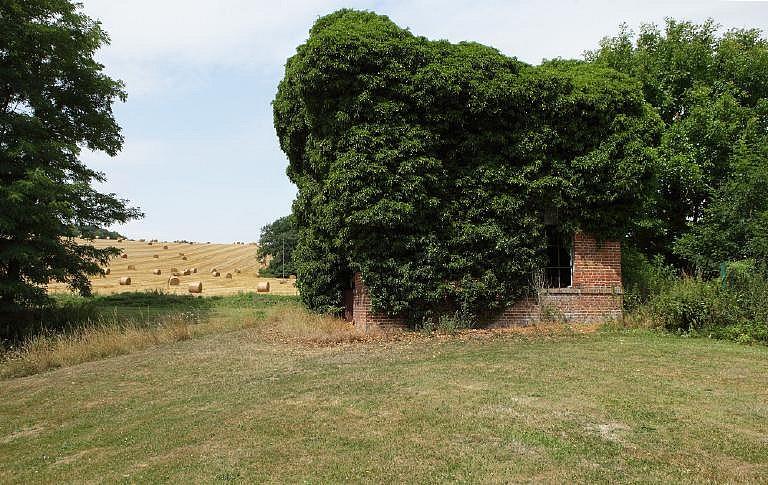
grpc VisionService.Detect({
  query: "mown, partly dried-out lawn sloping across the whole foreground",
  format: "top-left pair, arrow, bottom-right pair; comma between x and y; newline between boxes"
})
0,329 -> 768,482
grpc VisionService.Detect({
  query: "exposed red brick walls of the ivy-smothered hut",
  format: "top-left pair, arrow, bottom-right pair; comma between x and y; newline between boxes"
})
352,234 -> 622,330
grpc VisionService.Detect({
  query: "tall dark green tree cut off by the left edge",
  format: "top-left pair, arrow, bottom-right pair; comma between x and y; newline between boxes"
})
0,0 -> 141,311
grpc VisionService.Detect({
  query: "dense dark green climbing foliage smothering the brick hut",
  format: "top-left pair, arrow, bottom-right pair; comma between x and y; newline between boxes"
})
274,10 -> 660,322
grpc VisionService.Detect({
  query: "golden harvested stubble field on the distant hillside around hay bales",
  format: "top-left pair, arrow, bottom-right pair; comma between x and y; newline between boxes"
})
49,239 -> 297,295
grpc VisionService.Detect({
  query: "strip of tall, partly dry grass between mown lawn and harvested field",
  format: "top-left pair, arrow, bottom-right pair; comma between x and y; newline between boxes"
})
0,294 -> 356,378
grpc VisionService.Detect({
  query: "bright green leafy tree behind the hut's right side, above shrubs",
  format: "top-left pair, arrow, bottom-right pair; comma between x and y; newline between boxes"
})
587,19 -> 768,271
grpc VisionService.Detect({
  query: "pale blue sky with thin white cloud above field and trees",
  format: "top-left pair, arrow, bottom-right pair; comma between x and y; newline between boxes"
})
81,0 -> 768,242
